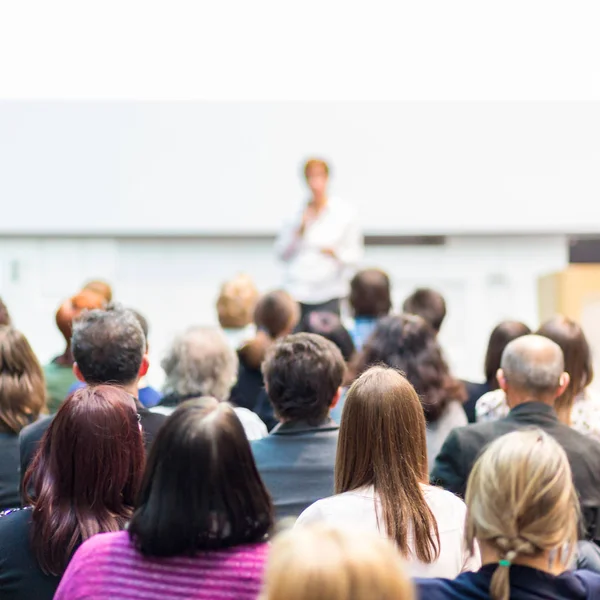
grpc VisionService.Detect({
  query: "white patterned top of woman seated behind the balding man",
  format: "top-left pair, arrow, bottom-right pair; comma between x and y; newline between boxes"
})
475,388 -> 600,442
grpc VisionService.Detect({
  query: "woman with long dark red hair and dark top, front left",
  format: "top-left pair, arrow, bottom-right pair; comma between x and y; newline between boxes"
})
0,386 -> 144,600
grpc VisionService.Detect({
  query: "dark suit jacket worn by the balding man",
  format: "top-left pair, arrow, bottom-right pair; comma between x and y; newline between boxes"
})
431,402 -> 600,540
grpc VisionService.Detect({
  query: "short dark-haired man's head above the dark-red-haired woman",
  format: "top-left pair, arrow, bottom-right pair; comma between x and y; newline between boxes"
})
72,307 -> 146,385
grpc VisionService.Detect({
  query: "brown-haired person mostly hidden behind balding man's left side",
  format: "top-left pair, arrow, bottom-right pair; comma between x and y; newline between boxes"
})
463,321 -> 531,423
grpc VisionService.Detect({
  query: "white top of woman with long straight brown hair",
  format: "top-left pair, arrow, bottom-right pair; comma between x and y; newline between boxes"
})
296,485 -> 481,579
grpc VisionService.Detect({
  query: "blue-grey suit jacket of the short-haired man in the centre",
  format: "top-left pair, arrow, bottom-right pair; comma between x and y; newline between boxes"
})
252,419 -> 339,519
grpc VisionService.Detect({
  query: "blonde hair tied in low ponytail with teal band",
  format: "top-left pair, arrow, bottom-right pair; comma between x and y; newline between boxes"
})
465,429 -> 579,600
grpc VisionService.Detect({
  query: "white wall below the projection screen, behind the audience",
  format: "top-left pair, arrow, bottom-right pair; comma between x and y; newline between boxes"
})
0,235 -> 568,384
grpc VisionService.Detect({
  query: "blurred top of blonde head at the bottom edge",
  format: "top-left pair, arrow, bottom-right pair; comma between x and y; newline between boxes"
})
261,524 -> 415,600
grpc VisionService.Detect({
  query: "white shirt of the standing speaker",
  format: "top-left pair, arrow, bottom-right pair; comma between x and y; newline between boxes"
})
275,198 -> 363,304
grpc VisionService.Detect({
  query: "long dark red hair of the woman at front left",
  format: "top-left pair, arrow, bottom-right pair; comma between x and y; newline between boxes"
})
23,386 -> 144,575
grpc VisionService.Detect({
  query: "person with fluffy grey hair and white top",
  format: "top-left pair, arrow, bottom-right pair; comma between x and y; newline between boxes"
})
152,327 -> 267,440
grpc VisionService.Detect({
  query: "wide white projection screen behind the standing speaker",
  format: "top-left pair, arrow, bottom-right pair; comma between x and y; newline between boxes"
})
0,101 -> 600,235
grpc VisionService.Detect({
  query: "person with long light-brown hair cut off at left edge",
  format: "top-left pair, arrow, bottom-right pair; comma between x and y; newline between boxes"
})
0,325 -> 46,511
